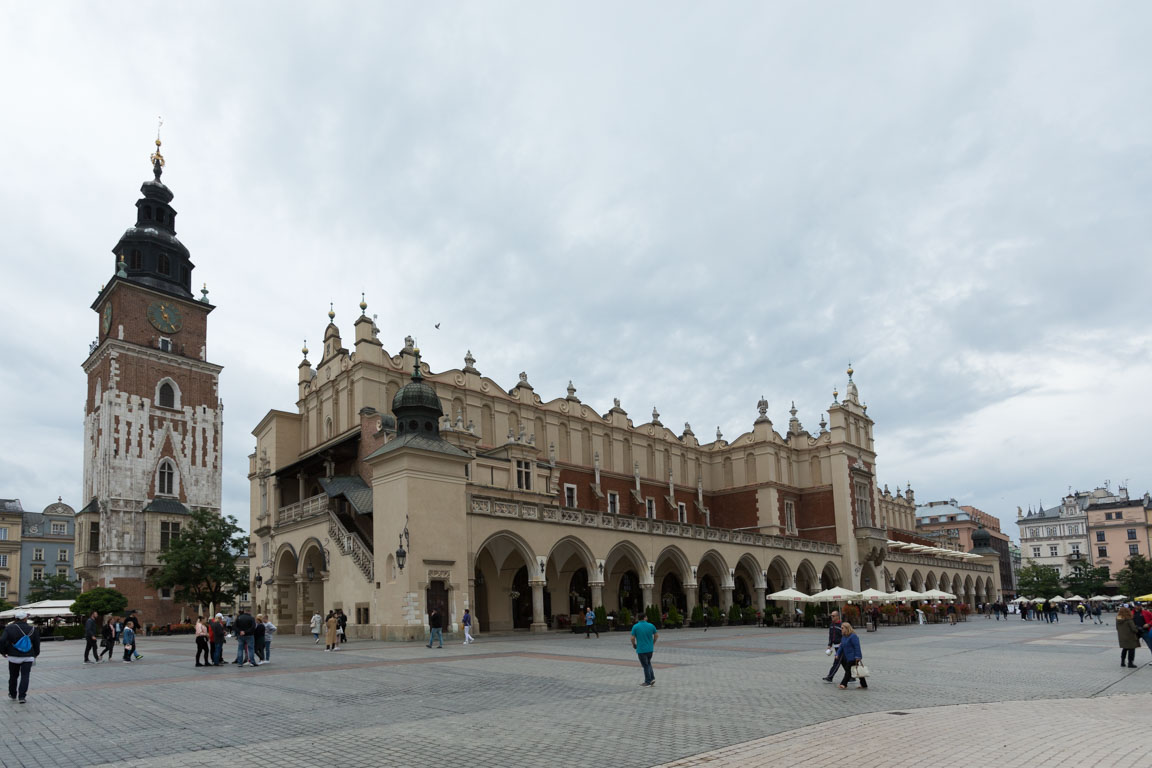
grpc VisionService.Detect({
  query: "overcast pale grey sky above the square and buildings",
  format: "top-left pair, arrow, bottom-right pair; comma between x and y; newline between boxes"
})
0,1 -> 1152,538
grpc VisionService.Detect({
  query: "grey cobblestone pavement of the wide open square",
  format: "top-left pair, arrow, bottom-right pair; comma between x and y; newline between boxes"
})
0,617 -> 1152,768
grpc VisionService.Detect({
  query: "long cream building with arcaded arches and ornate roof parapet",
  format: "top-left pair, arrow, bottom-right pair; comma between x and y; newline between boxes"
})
249,302 -> 1000,639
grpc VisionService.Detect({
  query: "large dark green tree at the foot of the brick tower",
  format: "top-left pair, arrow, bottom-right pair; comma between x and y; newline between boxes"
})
149,509 -> 248,604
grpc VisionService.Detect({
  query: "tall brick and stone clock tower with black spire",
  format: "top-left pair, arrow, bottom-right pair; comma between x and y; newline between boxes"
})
76,138 -> 222,623
